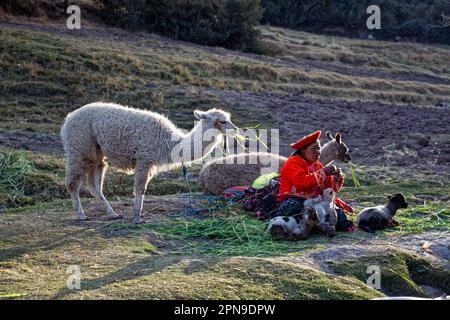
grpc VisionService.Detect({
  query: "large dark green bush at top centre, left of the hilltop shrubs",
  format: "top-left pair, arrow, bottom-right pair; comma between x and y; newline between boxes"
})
104,0 -> 262,51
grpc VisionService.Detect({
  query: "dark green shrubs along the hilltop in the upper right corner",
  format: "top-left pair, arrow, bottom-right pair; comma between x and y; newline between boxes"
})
261,0 -> 450,43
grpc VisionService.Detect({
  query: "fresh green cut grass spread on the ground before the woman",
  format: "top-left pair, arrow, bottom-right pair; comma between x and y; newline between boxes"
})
109,208 -> 327,257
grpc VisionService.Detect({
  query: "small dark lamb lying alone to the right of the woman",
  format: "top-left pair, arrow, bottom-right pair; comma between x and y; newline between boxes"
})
358,193 -> 408,233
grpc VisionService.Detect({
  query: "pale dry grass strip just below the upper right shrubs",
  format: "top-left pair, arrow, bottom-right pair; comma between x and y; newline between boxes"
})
263,27 -> 450,79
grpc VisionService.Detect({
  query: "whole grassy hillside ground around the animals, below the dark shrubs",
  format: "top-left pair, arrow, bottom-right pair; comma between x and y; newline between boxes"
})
0,22 -> 450,299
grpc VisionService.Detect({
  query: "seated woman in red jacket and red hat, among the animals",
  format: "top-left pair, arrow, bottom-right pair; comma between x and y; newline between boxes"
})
277,131 -> 353,233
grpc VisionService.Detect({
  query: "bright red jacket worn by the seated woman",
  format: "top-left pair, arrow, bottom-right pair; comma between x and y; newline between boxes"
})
277,155 -> 344,202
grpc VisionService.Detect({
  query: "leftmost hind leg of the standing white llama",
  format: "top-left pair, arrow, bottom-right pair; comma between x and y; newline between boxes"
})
65,158 -> 90,220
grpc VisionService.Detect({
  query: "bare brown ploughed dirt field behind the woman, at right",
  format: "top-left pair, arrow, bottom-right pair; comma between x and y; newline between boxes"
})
207,90 -> 450,174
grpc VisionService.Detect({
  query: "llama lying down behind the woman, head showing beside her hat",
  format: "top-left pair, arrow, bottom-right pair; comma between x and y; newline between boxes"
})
198,132 -> 352,195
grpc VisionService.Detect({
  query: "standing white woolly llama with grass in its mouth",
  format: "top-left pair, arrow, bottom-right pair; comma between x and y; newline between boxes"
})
61,102 -> 235,224
